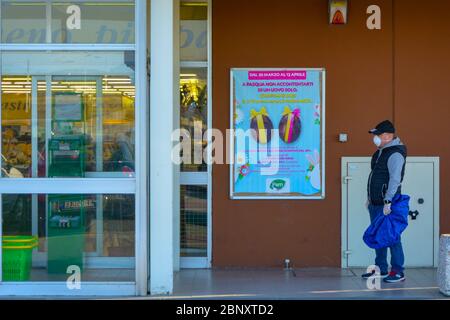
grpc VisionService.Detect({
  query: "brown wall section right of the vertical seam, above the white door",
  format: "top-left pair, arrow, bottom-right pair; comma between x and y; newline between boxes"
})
394,0 -> 450,239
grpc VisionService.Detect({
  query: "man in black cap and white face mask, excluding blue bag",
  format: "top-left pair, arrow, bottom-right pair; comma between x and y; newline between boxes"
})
362,120 -> 407,283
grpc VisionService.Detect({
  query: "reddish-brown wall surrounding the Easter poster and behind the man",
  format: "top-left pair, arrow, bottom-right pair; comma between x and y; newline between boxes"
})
212,0 -> 450,267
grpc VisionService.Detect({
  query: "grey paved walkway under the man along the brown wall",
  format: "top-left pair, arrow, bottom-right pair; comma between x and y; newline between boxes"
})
139,268 -> 450,300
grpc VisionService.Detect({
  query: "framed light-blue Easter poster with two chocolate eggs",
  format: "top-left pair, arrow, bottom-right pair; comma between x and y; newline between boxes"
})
230,68 -> 325,199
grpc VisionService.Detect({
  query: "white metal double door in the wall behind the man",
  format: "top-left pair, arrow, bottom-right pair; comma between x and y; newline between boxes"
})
342,157 -> 439,267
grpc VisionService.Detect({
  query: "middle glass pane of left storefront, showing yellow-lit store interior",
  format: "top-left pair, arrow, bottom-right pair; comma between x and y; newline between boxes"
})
1,52 -> 136,178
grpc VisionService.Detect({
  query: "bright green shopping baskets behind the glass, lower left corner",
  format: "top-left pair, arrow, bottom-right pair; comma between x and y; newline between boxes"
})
2,236 -> 38,281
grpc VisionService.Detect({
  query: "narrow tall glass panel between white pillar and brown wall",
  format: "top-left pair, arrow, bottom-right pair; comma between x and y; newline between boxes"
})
180,1 -> 211,268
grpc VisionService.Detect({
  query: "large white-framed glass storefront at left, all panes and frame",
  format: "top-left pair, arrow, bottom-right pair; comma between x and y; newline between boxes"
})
0,0 -> 148,296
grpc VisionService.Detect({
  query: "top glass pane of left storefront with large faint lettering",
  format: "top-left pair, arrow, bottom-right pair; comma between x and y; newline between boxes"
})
1,0 -> 135,44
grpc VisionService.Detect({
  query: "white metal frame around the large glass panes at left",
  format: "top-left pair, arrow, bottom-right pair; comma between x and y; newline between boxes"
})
0,0 -> 148,296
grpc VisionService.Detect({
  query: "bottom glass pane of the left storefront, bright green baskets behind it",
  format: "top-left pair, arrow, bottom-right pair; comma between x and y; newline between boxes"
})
0,194 -> 135,282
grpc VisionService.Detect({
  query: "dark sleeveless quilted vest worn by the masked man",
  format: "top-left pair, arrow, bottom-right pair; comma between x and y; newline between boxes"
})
367,145 -> 407,205
